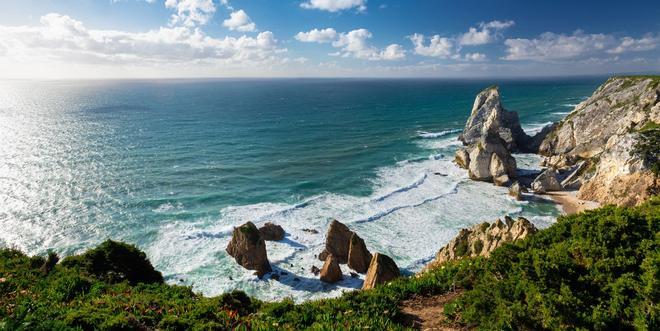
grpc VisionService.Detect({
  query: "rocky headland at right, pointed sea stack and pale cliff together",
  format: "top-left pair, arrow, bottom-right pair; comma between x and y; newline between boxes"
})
455,77 -> 660,209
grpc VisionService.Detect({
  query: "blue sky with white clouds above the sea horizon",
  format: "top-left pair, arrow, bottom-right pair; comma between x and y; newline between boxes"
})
0,0 -> 660,79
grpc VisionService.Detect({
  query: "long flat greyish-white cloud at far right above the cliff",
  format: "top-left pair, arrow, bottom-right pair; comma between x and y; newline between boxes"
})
504,30 -> 660,61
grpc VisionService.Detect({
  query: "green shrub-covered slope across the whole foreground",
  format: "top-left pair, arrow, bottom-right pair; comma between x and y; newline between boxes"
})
0,197 -> 660,330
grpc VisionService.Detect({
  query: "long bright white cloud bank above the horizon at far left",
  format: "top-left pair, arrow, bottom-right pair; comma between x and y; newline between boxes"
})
0,13 -> 286,66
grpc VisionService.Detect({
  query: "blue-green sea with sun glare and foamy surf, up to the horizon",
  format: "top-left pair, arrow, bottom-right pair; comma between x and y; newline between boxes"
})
0,78 -> 604,300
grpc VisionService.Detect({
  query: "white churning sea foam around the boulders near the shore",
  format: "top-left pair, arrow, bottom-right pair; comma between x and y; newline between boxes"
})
146,130 -> 552,301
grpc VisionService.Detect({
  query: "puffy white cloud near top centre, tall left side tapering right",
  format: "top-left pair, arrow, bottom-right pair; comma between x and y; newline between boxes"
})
331,29 -> 405,60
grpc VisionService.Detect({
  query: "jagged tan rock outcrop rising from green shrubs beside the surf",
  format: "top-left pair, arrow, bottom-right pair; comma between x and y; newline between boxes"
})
425,216 -> 536,269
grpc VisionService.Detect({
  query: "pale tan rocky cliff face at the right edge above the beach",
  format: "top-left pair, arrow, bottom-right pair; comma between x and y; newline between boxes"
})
539,77 -> 660,205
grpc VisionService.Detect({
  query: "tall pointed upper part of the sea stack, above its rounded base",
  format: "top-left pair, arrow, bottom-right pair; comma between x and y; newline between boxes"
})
458,86 -> 531,151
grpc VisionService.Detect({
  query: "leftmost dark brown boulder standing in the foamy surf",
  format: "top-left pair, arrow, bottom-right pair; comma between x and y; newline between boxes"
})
227,222 -> 272,278
